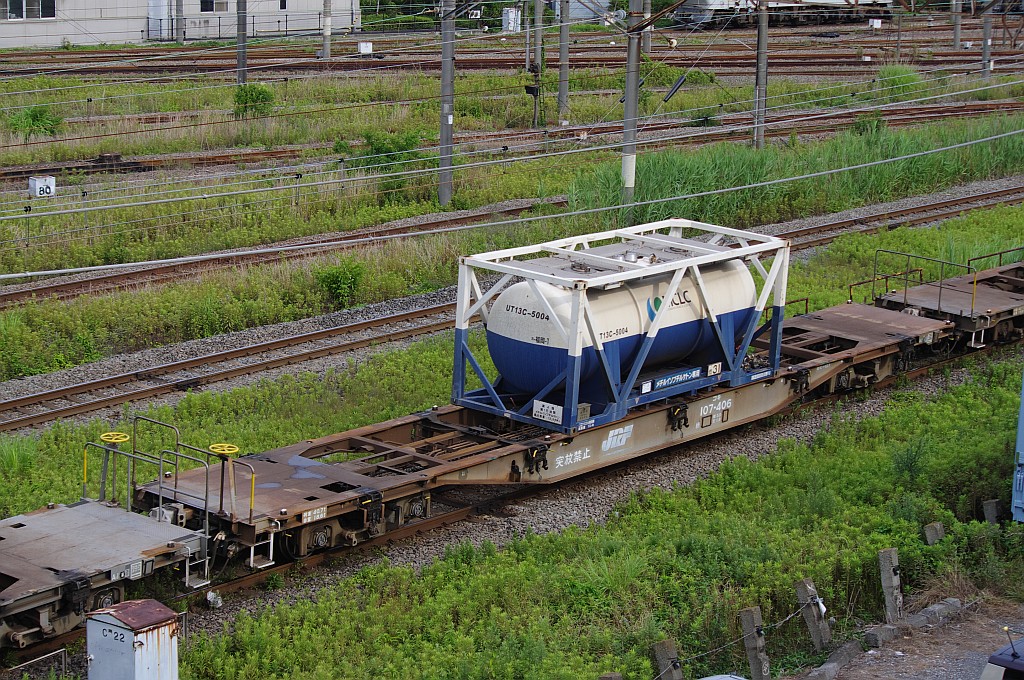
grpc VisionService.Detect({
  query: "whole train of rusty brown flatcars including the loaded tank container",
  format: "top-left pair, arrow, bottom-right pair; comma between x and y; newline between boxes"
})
0,219 -> 1024,646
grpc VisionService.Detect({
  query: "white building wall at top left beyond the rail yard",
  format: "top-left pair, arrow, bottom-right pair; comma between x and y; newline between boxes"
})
0,0 -> 361,48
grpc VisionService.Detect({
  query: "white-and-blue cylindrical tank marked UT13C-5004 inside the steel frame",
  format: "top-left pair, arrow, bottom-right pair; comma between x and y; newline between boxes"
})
486,260 -> 757,394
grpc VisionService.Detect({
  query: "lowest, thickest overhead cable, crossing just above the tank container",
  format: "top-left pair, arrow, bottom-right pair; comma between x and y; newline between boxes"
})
0,121 -> 1024,281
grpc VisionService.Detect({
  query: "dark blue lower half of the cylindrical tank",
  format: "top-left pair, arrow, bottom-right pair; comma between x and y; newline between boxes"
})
487,308 -> 755,401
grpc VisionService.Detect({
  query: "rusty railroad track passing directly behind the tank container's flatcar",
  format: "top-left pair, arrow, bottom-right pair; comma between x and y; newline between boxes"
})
0,185 -> 1024,431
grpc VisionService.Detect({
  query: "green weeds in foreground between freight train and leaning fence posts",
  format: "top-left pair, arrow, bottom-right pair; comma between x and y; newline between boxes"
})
181,359 -> 1024,680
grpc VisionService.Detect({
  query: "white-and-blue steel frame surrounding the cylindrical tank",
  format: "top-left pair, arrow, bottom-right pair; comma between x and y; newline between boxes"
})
452,219 -> 790,433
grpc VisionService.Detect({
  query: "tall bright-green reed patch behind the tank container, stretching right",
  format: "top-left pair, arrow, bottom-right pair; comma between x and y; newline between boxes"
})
569,116 -> 1024,227
